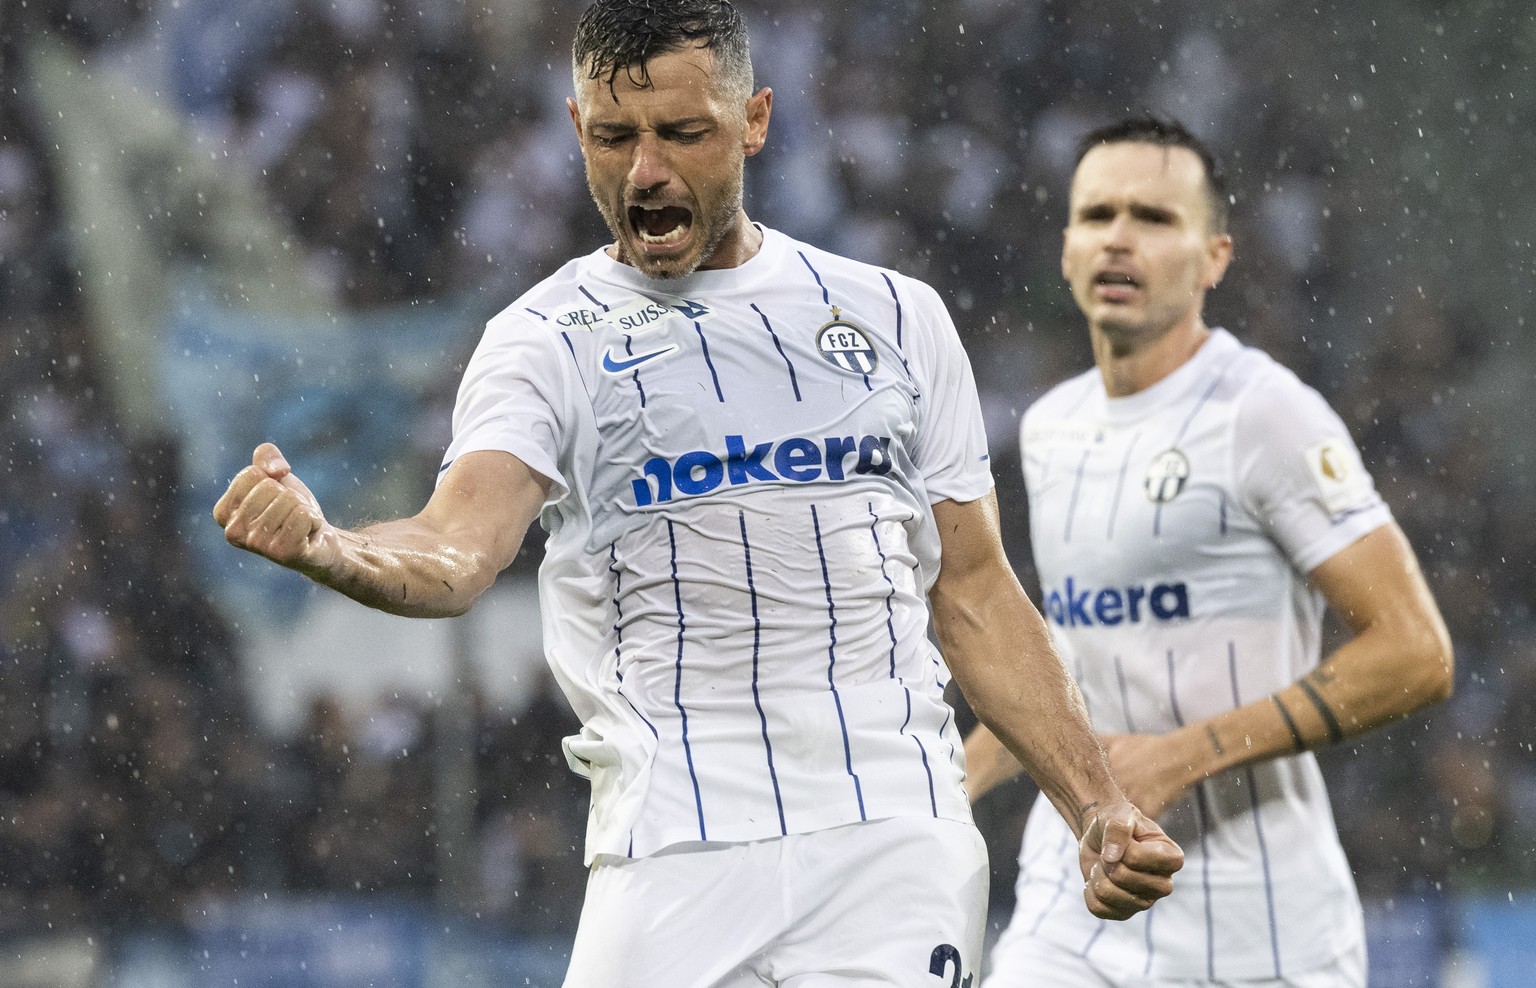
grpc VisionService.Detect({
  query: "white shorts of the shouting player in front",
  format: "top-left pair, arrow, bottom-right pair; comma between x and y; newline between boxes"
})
565,817 -> 988,988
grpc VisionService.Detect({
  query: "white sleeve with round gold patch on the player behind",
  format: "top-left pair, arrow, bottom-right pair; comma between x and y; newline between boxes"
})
1232,372 -> 1392,573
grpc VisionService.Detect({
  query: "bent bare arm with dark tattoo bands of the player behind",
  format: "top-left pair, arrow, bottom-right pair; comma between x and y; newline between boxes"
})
1104,522 -> 1453,814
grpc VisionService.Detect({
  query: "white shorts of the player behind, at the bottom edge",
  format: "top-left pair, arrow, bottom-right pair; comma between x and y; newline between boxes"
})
982,933 -> 1366,988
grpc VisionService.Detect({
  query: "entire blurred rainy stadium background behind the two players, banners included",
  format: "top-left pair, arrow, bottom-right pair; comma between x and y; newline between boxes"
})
0,0 -> 1536,988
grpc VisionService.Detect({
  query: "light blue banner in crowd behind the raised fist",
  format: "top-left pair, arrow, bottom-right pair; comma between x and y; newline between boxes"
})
157,279 -> 487,612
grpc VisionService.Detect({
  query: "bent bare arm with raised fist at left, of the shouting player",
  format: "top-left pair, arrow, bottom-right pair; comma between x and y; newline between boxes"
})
214,443 -> 550,618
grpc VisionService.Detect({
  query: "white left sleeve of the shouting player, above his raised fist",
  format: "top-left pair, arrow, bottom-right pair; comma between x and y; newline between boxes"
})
438,308 -> 570,501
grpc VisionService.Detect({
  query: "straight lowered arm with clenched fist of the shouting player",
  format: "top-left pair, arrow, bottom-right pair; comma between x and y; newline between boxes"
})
929,493 -> 1184,919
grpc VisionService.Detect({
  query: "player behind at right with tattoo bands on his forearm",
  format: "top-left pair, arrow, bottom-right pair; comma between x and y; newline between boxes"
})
966,118 -> 1452,988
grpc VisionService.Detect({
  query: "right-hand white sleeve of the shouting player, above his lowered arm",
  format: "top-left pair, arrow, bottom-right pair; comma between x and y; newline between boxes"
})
902,280 -> 992,502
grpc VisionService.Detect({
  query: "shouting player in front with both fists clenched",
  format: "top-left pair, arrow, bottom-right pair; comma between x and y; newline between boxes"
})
214,0 -> 1183,988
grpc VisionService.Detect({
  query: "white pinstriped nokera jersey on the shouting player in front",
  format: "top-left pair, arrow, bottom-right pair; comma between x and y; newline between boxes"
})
444,229 -> 992,860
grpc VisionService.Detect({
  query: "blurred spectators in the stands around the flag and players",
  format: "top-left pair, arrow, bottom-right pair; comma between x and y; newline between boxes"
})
0,0 -> 1536,952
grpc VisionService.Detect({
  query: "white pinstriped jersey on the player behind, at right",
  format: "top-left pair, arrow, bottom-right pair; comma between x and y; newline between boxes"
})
1012,330 -> 1390,980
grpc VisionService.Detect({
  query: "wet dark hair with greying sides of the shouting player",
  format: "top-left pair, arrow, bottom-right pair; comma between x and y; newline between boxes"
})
571,0 -> 753,104
